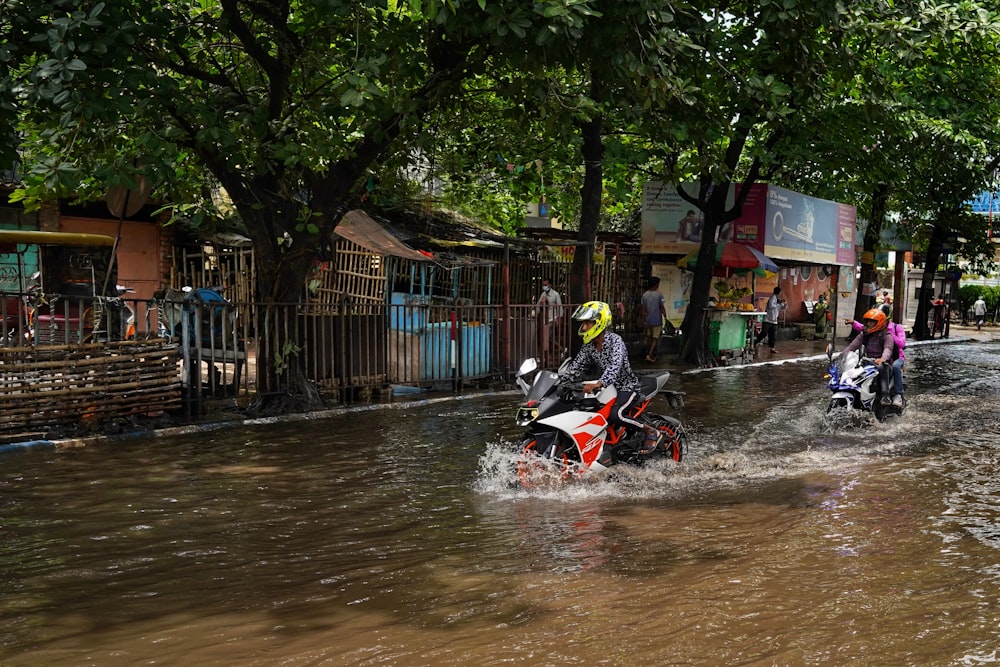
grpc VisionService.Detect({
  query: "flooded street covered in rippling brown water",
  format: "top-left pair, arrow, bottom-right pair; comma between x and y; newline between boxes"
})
0,343 -> 1000,666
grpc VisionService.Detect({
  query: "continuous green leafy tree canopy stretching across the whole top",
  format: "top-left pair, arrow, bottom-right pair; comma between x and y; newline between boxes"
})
0,0 -> 1000,392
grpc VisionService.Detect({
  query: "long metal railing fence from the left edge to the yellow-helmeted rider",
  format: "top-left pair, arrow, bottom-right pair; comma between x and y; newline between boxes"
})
0,289 -> 648,416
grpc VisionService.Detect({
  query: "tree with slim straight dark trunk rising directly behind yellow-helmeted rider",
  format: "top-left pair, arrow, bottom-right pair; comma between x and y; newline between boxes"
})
404,0 -> 703,310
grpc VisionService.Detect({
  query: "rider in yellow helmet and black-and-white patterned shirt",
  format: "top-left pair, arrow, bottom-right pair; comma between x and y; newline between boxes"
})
564,301 -> 663,454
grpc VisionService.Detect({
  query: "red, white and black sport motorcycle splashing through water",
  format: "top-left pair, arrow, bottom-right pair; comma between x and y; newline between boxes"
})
516,359 -> 687,488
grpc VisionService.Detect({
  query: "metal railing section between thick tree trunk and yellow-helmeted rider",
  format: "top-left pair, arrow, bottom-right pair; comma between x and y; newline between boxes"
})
257,295 -> 571,400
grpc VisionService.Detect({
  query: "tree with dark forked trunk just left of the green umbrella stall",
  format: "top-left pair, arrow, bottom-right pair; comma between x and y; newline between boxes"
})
663,0 -> 855,365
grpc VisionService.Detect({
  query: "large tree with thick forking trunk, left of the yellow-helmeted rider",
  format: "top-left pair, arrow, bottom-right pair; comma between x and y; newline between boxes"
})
0,0 -> 590,411
